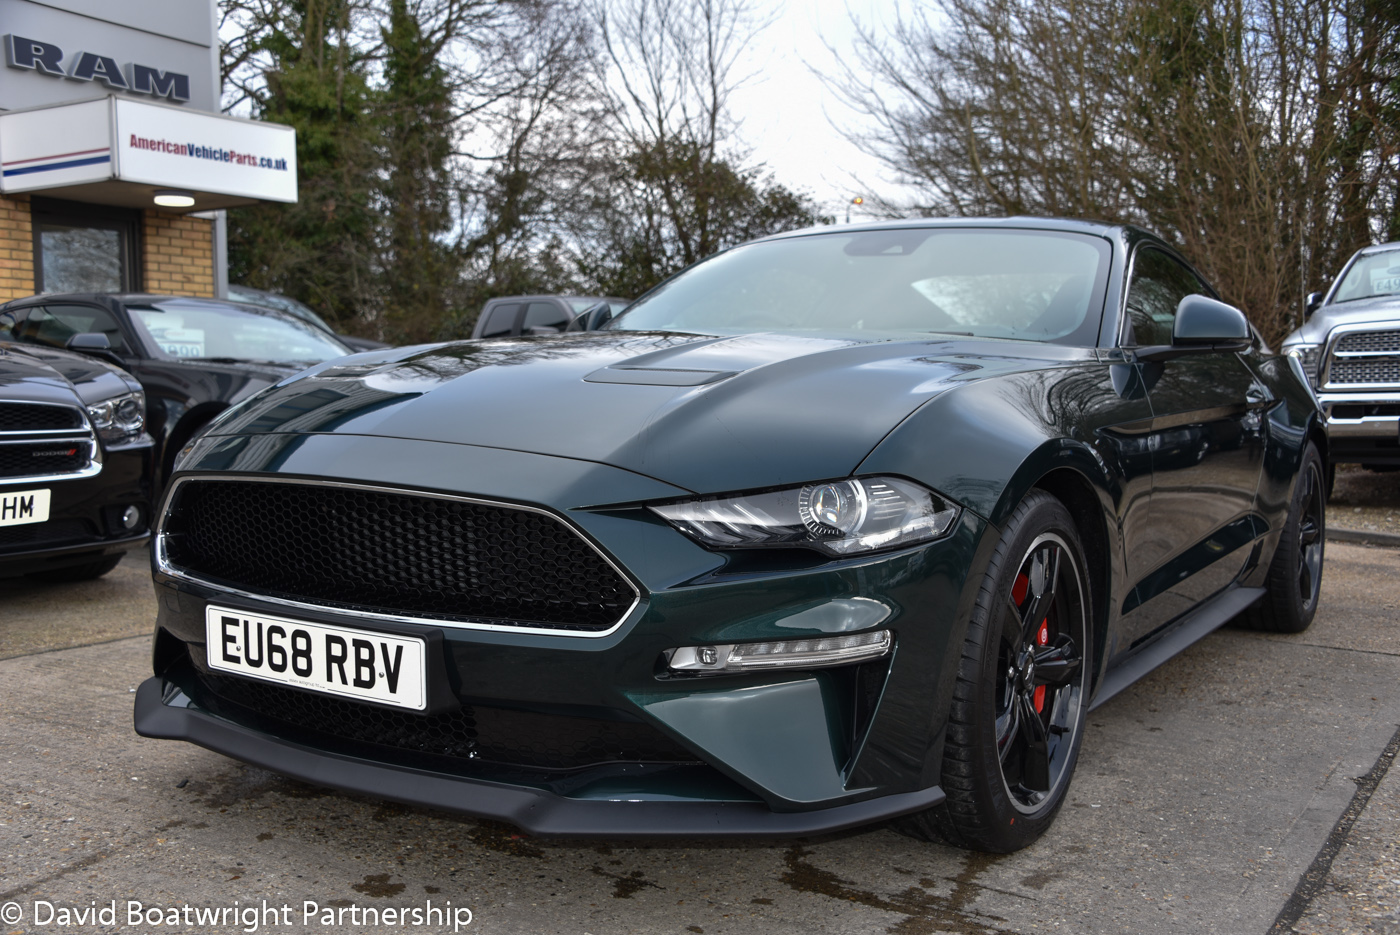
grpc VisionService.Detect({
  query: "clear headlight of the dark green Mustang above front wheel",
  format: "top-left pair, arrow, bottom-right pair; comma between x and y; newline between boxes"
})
651,477 -> 958,556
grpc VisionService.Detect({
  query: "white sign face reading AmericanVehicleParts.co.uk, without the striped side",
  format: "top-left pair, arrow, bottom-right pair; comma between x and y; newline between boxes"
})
116,99 -> 297,202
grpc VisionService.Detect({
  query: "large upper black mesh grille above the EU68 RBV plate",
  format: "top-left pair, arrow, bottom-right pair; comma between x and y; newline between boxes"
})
165,480 -> 636,631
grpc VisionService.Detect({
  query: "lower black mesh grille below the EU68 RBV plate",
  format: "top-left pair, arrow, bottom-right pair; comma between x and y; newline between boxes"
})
185,672 -> 696,770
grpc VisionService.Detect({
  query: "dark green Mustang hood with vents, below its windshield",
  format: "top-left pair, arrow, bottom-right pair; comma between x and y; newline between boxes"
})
210,332 -> 1084,493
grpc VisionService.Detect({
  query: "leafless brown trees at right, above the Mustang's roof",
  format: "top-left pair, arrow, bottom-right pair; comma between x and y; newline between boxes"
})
833,0 -> 1400,337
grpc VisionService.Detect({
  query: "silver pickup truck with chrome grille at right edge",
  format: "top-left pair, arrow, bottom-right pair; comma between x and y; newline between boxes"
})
1284,242 -> 1400,468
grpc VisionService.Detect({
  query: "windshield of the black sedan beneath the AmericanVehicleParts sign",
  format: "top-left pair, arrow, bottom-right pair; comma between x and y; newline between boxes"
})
127,301 -> 350,364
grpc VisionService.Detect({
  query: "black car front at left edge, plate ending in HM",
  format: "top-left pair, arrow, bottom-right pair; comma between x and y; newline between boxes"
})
0,342 -> 154,581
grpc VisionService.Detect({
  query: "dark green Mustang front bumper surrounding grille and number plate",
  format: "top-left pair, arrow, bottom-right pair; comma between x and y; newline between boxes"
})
136,437 -> 990,837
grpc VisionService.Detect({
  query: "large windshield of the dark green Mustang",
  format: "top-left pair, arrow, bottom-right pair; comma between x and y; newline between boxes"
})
608,228 -> 1110,346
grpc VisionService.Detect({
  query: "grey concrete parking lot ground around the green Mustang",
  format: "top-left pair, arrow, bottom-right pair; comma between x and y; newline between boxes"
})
0,543 -> 1400,935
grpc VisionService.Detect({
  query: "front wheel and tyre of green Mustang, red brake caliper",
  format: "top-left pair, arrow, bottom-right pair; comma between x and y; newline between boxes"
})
896,490 -> 1093,854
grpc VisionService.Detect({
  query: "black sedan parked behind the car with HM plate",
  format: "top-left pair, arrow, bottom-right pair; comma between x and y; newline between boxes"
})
0,293 -> 353,480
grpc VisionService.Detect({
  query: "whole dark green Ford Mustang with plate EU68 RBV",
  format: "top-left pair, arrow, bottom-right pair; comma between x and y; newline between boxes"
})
136,218 -> 1326,851
